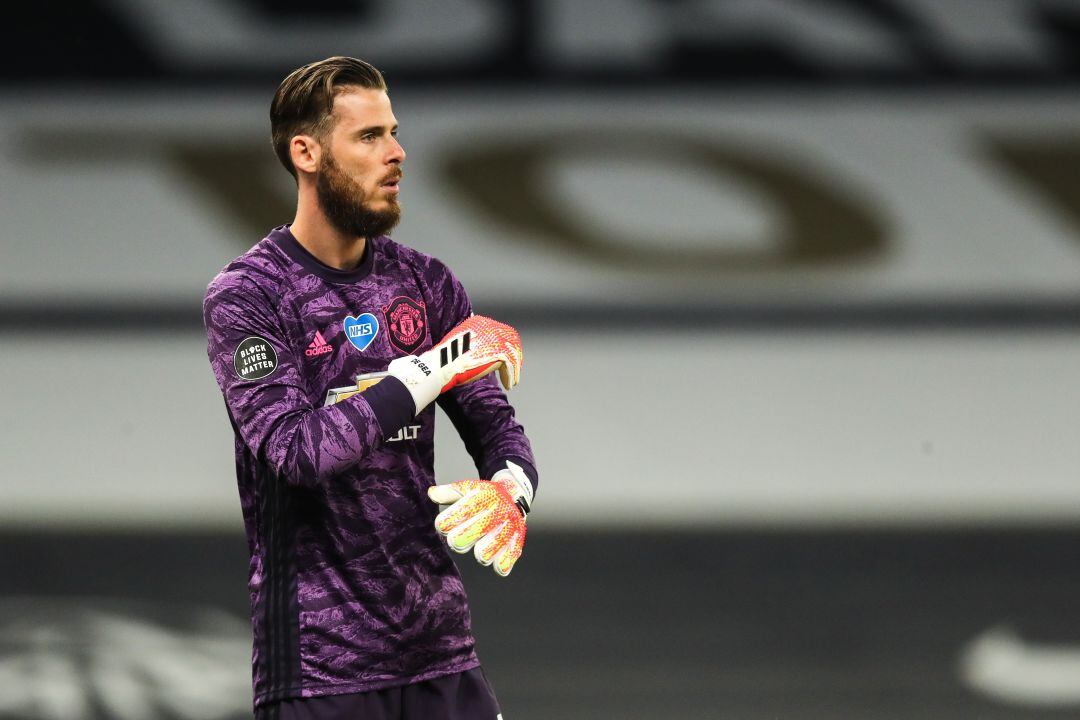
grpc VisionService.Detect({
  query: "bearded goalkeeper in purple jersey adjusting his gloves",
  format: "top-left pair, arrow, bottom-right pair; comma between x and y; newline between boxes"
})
203,57 -> 537,720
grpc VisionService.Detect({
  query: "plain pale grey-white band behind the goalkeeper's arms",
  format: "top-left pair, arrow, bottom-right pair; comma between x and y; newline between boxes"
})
0,329 -> 1080,527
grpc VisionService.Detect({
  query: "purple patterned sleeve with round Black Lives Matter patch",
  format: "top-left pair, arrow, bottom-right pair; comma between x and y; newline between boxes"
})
203,273 -> 384,486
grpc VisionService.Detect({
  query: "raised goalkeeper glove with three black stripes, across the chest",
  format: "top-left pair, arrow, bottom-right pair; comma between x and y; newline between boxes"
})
387,315 -> 522,415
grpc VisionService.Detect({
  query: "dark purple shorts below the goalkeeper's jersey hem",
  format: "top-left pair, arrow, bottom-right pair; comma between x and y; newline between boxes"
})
255,667 -> 502,720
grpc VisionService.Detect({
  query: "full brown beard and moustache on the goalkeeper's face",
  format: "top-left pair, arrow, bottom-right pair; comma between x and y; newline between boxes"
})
315,152 -> 402,237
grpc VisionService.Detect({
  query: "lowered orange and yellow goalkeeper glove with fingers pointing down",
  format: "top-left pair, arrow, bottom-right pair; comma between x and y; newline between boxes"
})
428,461 -> 532,576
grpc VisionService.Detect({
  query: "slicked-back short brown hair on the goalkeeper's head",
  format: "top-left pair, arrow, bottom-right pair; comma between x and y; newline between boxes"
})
270,55 -> 387,179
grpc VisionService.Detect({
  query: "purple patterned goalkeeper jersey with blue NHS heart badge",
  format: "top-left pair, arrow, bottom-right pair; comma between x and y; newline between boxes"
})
203,226 -> 536,705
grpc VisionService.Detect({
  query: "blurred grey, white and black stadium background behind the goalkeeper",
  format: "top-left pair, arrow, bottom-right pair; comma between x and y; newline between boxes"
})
0,0 -> 1080,720
